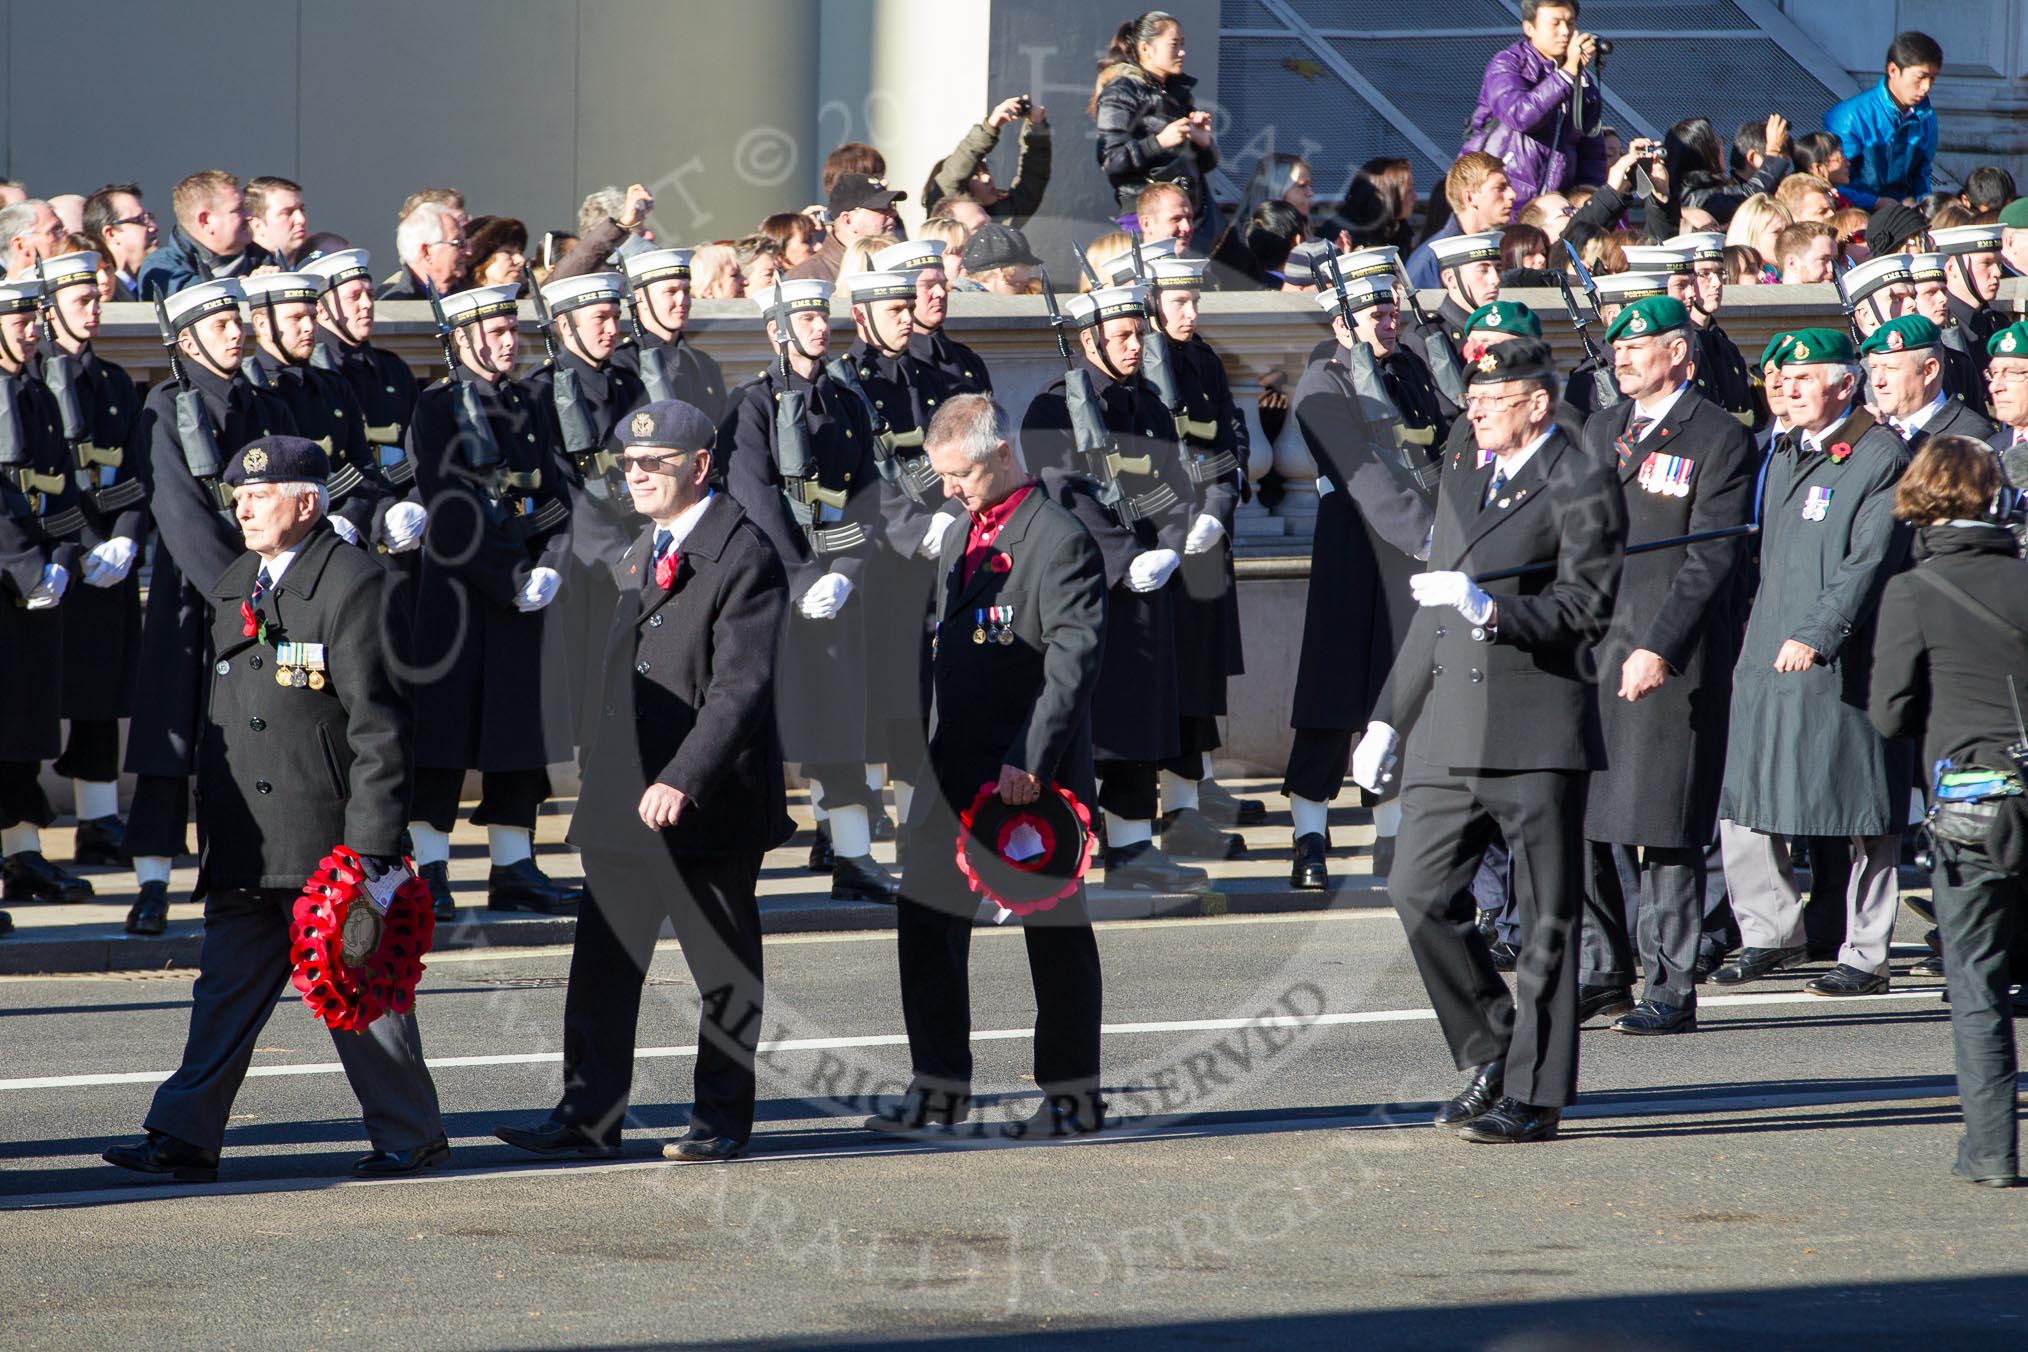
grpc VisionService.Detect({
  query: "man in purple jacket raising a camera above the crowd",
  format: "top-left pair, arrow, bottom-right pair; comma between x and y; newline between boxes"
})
1464,0 -> 1606,211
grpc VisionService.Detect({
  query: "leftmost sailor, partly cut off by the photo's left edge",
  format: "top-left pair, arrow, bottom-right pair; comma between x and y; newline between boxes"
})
0,276 -> 91,932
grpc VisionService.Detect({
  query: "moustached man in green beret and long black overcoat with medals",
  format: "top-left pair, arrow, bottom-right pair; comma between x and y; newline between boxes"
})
1578,296 -> 1756,1034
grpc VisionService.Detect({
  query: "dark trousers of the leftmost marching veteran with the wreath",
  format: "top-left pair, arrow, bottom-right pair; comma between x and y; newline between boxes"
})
146,888 -> 444,1151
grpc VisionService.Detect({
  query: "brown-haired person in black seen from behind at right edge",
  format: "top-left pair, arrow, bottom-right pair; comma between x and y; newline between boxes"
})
1866,436 -> 2028,1188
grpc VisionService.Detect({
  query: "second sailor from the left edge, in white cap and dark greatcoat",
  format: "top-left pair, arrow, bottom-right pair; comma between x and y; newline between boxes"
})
32,253 -> 146,887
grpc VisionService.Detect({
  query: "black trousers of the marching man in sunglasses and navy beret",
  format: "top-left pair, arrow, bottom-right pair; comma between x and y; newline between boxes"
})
554,849 -> 763,1145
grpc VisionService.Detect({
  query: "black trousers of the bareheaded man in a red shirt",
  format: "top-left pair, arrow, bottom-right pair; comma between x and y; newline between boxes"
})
896,803 -> 1103,1097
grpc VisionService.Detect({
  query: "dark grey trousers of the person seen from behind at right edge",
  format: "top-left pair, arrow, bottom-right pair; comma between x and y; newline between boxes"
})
1933,841 -> 2028,1178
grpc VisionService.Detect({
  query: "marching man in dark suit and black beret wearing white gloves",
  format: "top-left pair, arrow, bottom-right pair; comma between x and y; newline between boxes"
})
1353,339 -> 1626,1143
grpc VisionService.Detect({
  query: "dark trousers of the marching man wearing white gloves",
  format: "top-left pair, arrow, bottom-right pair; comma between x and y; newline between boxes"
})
1387,766 -> 1588,1107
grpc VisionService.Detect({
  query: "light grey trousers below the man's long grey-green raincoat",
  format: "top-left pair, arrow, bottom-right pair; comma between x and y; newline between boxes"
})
1718,821 -> 1900,973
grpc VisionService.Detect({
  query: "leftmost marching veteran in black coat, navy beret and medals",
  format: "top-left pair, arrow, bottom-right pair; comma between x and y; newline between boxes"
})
105,436 -> 450,1182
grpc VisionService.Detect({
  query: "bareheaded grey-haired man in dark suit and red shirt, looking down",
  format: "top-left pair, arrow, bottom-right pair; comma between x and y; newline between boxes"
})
866,395 -> 1107,1135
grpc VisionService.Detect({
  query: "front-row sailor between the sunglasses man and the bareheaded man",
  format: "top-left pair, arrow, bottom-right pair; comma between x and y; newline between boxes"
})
718,278 -> 896,902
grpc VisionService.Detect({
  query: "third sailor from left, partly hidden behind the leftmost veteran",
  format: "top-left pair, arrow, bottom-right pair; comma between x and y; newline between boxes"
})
126,278 -> 296,926
